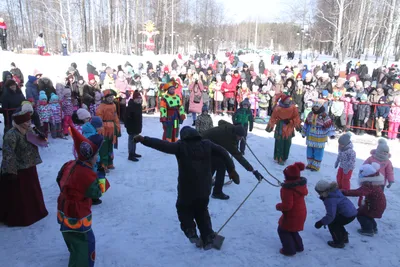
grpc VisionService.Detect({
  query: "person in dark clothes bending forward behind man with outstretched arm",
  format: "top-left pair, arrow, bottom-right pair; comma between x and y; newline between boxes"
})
202,120 -> 262,200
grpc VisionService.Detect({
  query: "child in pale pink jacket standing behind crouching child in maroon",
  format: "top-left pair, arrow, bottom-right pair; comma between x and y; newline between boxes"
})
364,139 -> 394,190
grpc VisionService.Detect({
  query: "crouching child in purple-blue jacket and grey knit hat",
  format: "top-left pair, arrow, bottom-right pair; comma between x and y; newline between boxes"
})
315,180 -> 357,248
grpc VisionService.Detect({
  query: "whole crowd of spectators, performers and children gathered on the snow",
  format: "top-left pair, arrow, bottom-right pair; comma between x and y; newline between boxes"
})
0,50 -> 400,266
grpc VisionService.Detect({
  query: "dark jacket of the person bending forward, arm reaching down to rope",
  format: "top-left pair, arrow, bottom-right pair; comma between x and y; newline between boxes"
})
202,120 -> 253,171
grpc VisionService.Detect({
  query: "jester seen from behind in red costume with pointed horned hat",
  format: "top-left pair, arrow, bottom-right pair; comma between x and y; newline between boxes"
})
57,127 -> 103,267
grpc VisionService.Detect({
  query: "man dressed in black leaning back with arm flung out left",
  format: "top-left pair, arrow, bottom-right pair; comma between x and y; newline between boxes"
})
135,126 -> 239,249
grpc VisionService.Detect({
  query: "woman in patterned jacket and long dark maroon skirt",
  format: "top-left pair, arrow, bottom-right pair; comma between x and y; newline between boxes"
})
0,110 -> 48,226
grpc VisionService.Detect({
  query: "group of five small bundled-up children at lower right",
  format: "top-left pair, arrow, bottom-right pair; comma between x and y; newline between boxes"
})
276,133 -> 394,256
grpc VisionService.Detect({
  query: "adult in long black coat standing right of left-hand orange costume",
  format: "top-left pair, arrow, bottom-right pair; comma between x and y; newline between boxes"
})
124,90 -> 143,162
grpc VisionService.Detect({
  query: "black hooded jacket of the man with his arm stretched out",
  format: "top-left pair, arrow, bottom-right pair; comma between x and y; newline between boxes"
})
142,127 -> 235,202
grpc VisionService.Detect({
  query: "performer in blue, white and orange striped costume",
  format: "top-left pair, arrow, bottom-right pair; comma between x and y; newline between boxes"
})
302,102 -> 335,171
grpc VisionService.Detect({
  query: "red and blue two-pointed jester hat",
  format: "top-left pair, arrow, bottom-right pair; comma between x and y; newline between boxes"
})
70,127 -> 104,161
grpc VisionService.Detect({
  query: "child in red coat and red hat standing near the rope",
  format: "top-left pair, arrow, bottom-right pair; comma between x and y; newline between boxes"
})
276,162 -> 308,256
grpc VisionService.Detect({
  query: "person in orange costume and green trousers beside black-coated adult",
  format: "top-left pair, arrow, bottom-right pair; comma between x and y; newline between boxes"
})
96,89 -> 121,172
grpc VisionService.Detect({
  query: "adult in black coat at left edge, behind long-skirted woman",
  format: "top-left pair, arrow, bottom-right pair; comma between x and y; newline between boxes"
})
2,80 -> 25,133
